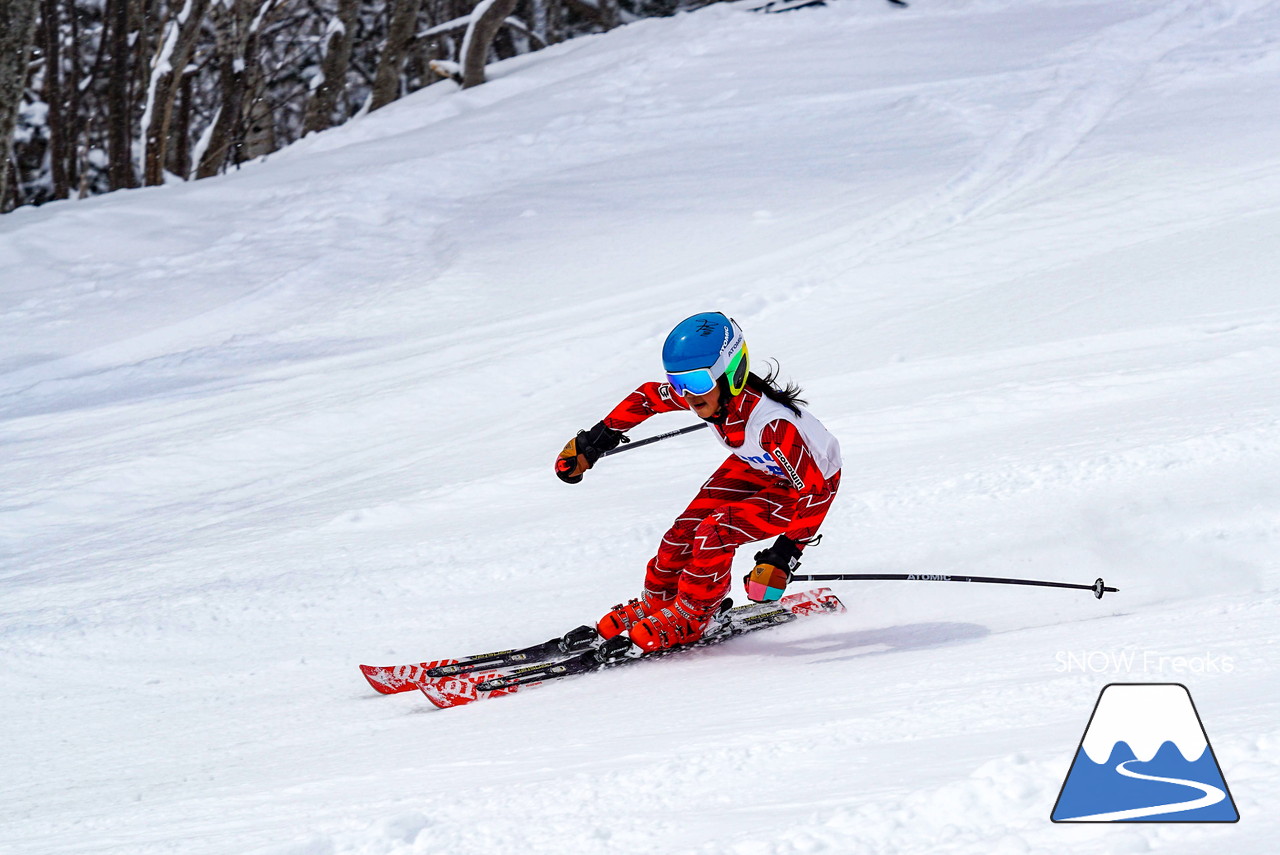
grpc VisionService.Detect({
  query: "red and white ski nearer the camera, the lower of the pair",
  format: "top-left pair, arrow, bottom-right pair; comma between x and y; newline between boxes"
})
417,587 -> 846,709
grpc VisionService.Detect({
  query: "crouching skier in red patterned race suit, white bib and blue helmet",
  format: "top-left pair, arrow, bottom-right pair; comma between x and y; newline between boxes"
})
556,312 -> 841,651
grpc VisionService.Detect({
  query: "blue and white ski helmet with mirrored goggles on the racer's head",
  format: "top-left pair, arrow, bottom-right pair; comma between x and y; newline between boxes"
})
662,312 -> 750,397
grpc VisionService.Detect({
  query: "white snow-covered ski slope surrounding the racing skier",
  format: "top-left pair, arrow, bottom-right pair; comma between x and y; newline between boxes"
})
0,0 -> 1280,855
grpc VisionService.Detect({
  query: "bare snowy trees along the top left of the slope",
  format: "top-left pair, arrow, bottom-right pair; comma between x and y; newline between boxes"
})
0,0 -> 700,211
